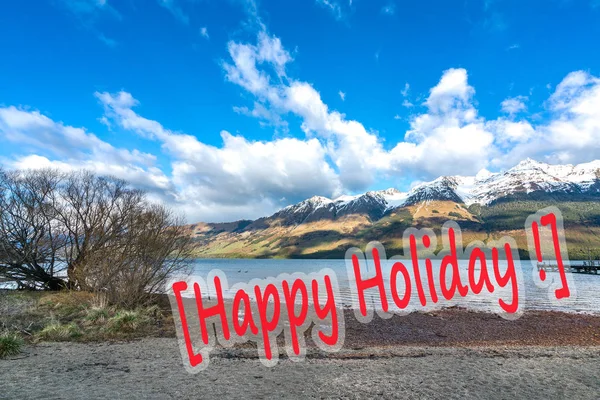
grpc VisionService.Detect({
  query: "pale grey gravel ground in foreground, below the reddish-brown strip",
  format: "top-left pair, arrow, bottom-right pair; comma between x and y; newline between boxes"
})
0,338 -> 600,399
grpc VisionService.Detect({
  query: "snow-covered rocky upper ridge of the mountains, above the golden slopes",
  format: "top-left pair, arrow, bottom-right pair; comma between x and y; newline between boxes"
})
272,158 -> 600,224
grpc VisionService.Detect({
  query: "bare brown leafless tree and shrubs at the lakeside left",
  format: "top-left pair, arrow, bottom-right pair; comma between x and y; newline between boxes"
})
0,170 -> 191,306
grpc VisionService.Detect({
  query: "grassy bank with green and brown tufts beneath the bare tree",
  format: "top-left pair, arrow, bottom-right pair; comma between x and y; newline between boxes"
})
0,291 -> 175,357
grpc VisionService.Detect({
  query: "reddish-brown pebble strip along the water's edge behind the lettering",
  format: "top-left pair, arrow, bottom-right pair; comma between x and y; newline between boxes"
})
168,298 -> 600,354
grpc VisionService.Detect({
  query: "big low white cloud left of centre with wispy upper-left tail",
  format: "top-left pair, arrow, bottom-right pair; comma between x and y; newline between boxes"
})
96,92 -> 340,221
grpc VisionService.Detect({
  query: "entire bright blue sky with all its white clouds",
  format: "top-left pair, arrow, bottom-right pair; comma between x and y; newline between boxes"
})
0,0 -> 600,221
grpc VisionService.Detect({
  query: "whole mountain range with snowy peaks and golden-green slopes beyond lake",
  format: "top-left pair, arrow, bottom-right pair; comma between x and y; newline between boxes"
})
188,159 -> 600,259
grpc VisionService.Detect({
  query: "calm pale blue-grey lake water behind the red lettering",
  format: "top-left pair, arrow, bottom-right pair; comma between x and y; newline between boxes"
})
184,259 -> 600,314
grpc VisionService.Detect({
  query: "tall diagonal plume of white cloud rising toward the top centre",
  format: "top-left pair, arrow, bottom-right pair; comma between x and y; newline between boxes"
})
223,32 -> 386,190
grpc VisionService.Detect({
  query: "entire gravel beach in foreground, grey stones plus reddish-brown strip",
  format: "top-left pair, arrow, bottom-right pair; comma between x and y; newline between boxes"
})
0,310 -> 600,399
